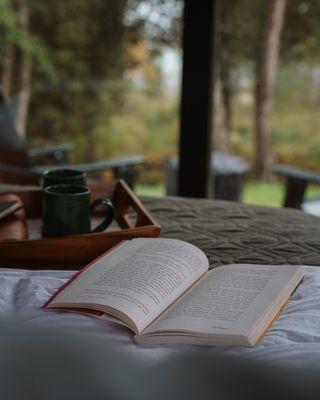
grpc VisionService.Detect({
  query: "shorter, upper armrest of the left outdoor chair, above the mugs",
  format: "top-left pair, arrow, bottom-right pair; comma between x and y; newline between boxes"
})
27,143 -> 73,165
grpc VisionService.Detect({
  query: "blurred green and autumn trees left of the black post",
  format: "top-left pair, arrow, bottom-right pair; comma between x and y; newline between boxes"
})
0,0 -> 179,165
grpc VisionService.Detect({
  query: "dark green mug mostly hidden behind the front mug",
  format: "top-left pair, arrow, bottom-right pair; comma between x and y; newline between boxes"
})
41,168 -> 87,189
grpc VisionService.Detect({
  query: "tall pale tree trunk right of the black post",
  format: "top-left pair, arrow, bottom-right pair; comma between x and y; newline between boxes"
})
255,0 -> 286,180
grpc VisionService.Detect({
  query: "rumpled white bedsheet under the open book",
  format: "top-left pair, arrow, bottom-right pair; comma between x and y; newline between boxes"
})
0,266 -> 320,365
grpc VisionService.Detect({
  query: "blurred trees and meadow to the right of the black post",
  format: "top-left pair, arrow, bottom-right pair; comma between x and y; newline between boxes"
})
216,0 -> 320,178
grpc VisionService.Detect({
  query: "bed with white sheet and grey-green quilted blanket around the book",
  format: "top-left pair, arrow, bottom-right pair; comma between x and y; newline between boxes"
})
0,197 -> 320,365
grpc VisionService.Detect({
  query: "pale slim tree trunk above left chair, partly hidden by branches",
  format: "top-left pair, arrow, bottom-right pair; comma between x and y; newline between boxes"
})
15,3 -> 32,137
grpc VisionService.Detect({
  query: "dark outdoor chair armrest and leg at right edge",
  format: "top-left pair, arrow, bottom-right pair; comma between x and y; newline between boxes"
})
273,165 -> 320,209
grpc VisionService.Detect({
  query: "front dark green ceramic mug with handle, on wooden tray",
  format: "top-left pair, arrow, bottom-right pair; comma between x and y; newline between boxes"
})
42,185 -> 114,237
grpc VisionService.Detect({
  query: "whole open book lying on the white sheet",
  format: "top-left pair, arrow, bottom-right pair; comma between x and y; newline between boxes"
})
44,238 -> 303,346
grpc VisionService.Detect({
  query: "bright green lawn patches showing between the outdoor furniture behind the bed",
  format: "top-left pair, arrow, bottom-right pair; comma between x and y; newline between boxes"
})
135,182 -> 320,207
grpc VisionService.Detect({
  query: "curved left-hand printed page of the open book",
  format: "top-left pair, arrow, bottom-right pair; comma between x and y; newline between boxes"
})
48,239 -> 209,332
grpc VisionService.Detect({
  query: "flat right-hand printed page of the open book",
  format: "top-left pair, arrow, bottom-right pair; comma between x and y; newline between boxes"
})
143,264 -> 302,335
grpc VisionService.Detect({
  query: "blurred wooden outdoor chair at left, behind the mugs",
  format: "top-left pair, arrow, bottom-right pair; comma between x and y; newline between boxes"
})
0,89 -> 144,187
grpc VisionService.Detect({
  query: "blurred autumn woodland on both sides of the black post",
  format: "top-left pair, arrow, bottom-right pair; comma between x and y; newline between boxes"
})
0,0 -> 320,202
